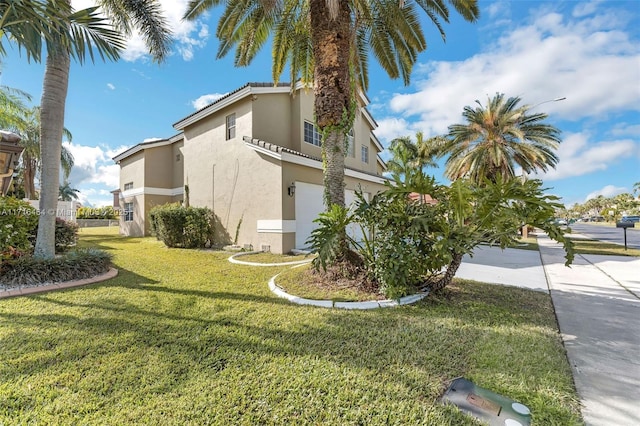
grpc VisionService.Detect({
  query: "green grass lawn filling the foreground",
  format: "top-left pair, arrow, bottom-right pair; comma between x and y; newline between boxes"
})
0,229 -> 581,425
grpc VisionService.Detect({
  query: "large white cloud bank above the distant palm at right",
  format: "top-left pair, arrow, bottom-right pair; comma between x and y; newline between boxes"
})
382,6 -> 640,134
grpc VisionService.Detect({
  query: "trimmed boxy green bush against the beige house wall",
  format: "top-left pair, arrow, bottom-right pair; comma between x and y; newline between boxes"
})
149,203 -> 214,248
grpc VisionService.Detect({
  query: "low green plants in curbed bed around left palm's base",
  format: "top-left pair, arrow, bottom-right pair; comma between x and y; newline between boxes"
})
0,249 -> 112,286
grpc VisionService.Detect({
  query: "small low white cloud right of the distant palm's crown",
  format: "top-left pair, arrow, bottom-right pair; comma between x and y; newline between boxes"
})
539,133 -> 640,181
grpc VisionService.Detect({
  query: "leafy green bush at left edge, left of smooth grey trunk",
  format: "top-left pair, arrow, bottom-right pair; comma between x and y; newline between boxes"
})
0,197 -> 38,259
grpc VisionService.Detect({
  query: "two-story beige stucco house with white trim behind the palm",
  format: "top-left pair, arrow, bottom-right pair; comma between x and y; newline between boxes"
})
114,83 -> 386,253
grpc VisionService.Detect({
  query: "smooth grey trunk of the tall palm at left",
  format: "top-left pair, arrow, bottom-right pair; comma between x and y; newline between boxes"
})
34,49 -> 71,259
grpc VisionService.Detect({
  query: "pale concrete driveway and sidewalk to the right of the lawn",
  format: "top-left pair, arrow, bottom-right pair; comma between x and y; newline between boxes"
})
456,236 -> 640,426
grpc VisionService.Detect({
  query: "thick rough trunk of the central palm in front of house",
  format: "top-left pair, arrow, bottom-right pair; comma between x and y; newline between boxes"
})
310,0 -> 354,209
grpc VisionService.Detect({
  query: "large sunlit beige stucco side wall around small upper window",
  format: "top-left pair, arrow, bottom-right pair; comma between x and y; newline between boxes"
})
182,96 -> 286,252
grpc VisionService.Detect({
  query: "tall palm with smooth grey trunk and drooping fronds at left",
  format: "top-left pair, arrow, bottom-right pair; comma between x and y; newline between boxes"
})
28,0 -> 170,258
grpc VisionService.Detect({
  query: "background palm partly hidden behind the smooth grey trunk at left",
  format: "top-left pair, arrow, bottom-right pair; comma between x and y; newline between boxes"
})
17,107 -> 74,200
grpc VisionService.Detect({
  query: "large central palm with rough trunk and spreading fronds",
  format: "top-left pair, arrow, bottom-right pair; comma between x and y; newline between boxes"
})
185,0 -> 479,210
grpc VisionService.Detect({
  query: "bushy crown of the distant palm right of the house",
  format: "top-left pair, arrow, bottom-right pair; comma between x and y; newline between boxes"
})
444,93 -> 561,183
